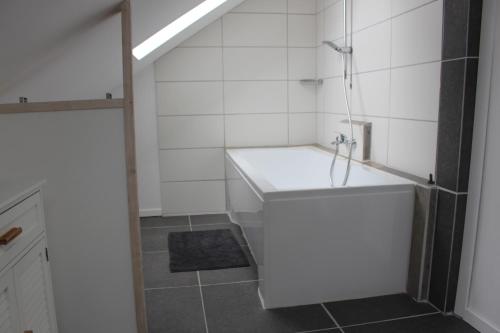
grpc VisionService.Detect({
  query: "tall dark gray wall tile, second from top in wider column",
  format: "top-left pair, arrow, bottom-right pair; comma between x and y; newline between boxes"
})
436,59 -> 465,191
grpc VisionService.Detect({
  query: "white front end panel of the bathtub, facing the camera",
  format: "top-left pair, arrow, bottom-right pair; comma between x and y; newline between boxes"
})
263,188 -> 414,308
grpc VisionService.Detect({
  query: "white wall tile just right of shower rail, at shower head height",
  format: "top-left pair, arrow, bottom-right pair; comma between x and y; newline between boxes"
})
352,21 -> 391,73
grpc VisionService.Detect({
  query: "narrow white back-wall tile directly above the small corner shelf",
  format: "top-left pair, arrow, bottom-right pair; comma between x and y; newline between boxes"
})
288,48 -> 316,80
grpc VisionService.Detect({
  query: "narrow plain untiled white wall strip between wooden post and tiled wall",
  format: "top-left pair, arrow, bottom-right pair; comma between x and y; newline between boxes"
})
134,66 -> 161,216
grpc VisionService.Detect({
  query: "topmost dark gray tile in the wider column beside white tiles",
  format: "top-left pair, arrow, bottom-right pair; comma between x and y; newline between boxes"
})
443,0 -> 469,59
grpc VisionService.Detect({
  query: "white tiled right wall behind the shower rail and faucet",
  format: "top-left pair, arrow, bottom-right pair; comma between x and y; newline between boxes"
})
316,0 -> 443,178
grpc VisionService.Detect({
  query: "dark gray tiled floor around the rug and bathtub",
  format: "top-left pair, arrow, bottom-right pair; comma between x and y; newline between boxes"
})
142,215 -> 477,333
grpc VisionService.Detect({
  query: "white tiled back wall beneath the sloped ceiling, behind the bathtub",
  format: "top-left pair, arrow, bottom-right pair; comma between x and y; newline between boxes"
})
155,0 -> 316,214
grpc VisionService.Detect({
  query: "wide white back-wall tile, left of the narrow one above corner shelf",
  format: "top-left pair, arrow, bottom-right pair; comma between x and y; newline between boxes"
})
224,48 -> 287,80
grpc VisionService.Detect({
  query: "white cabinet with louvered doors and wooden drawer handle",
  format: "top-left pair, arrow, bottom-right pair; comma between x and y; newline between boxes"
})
0,186 -> 57,333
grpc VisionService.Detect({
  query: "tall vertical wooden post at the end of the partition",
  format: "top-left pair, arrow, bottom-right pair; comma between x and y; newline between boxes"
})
121,0 -> 147,333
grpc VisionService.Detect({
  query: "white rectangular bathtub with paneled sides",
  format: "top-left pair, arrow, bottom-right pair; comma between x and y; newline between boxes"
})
226,146 -> 415,308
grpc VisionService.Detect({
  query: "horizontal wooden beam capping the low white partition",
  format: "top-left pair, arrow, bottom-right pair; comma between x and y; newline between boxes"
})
0,99 -> 124,114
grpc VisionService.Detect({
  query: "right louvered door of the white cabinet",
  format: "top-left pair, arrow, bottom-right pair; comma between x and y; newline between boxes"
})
13,240 -> 57,333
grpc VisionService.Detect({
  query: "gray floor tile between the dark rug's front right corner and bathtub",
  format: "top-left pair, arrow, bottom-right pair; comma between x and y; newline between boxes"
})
200,246 -> 258,284
